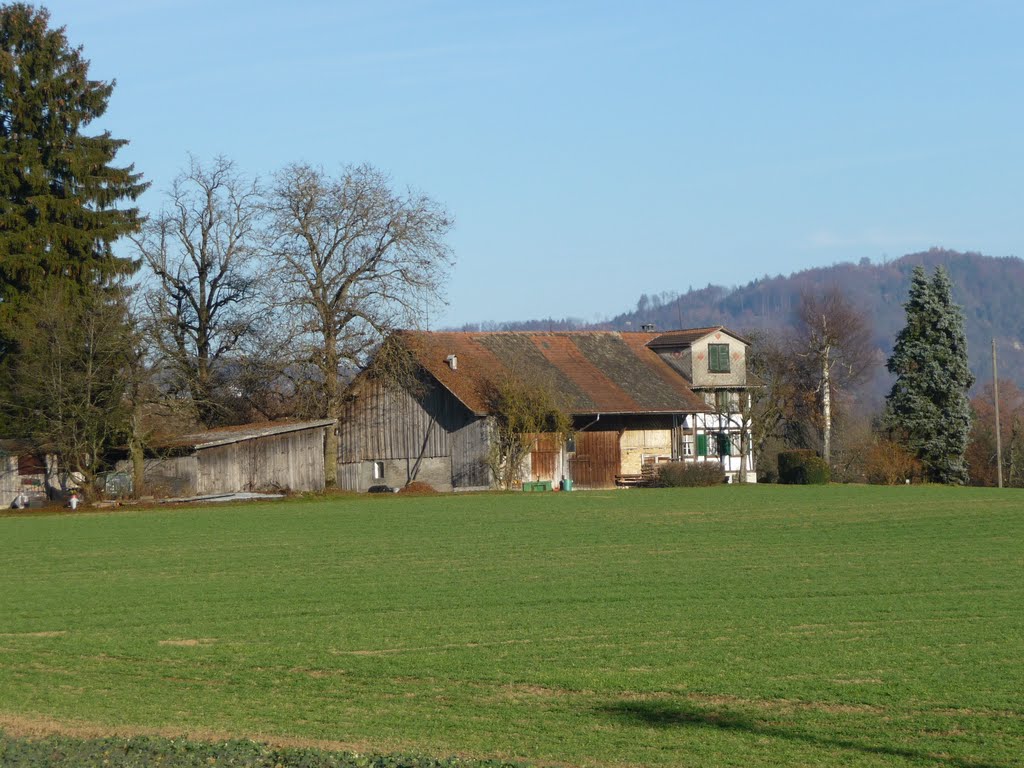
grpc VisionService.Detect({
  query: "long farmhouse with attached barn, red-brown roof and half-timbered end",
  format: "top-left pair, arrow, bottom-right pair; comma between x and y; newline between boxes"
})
338,327 -> 756,490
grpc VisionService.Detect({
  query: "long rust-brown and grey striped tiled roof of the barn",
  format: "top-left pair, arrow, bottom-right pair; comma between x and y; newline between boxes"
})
399,331 -> 709,415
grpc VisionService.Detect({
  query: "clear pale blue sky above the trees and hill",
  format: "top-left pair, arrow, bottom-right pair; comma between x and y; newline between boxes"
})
37,0 -> 1024,328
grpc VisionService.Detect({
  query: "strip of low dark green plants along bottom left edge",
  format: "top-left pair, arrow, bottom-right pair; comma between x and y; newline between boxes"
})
0,732 -> 523,768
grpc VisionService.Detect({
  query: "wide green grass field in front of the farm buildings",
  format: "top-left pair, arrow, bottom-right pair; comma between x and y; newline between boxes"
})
0,485 -> 1024,768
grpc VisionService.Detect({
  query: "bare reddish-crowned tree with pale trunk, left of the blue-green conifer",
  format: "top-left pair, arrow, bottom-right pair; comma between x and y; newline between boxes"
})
796,288 -> 878,465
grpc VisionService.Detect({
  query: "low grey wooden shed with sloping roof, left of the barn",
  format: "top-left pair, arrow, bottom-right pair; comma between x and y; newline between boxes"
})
118,419 -> 334,497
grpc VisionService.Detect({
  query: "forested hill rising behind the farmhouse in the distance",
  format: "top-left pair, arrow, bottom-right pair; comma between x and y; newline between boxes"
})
460,249 -> 1024,397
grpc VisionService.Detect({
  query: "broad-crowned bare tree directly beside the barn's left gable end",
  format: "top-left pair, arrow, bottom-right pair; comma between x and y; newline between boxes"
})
266,165 -> 453,485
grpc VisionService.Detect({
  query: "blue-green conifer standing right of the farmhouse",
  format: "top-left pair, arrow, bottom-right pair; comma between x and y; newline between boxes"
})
886,266 -> 974,484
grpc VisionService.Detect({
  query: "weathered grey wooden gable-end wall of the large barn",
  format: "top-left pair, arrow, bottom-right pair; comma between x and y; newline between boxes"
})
338,381 -> 490,490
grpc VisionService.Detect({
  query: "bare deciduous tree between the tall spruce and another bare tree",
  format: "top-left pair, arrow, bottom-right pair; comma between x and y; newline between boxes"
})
133,157 -> 265,425
